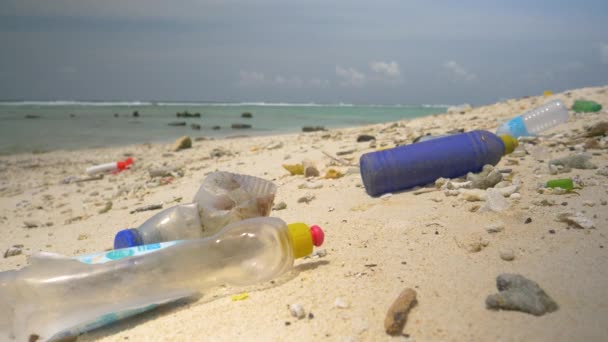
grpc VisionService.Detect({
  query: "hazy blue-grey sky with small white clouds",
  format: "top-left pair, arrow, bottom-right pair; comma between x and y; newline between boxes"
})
0,0 -> 608,104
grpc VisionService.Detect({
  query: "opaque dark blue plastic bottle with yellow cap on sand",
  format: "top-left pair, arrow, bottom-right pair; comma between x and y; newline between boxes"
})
359,131 -> 517,196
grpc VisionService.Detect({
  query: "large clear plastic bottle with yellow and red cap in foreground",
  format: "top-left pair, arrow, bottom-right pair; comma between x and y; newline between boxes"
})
0,217 -> 324,341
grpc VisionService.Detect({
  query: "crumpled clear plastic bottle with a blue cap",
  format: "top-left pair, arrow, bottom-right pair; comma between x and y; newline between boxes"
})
114,172 -> 277,249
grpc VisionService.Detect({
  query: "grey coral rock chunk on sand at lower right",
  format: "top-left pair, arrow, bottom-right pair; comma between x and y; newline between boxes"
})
486,273 -> 559,316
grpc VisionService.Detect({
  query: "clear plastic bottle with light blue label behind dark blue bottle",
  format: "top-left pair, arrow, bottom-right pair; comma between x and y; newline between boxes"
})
496,100 -> 568,138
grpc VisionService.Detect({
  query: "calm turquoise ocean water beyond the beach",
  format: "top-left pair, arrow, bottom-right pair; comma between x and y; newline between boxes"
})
0,101 -> 447,155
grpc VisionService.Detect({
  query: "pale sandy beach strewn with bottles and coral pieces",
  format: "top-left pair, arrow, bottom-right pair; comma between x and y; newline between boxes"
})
0,87 -> 608,341
